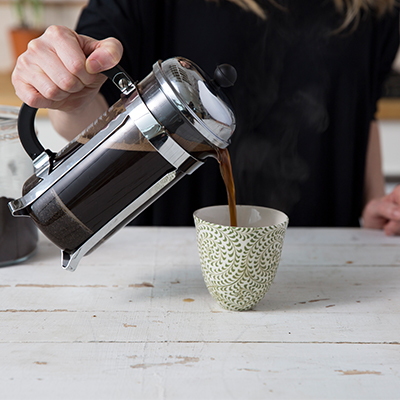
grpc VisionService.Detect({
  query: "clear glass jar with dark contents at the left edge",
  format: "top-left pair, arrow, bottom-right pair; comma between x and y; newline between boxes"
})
0,106 -> 38,266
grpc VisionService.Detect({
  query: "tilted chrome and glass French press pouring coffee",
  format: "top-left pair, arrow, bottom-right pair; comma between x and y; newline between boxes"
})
9,57 -> 236,271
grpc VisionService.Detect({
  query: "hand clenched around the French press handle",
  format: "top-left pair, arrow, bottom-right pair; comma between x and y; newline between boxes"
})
12,26 -> 123,114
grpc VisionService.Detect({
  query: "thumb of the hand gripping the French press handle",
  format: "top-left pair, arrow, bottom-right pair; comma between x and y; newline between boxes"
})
81,36 -> 123,74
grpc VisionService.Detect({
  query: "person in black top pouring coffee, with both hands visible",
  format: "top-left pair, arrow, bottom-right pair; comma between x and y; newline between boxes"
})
12,0 -> 400,235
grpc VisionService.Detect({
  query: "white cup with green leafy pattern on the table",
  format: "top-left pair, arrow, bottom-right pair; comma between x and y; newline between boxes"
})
194,206 -> 289,311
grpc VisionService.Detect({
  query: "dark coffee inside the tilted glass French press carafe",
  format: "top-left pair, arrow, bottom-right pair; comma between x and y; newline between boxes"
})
28,99 -> 178,252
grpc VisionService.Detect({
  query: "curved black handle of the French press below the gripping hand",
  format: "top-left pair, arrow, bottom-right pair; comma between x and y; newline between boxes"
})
18,103 -> 45,160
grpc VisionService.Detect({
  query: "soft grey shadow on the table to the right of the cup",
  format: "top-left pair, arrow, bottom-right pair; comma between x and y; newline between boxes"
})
255,266 -> 400,312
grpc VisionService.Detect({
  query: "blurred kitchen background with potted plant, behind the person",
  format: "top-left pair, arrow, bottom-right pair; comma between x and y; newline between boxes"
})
0,0 -> 400,191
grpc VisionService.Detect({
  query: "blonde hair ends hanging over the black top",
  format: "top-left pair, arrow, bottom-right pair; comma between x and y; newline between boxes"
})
208,0 -> 396,31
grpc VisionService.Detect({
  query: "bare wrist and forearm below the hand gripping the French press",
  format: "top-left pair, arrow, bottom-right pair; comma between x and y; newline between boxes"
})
48,93 -> 108,141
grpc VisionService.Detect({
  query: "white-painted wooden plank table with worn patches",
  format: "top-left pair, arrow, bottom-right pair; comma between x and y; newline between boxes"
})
0,228 -> 400,400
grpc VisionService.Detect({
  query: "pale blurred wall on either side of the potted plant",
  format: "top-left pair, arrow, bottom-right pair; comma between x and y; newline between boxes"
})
0,0 -> 87,73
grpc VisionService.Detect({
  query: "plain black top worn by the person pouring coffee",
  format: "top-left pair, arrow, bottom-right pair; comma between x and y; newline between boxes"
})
77,0 -> 399,226
